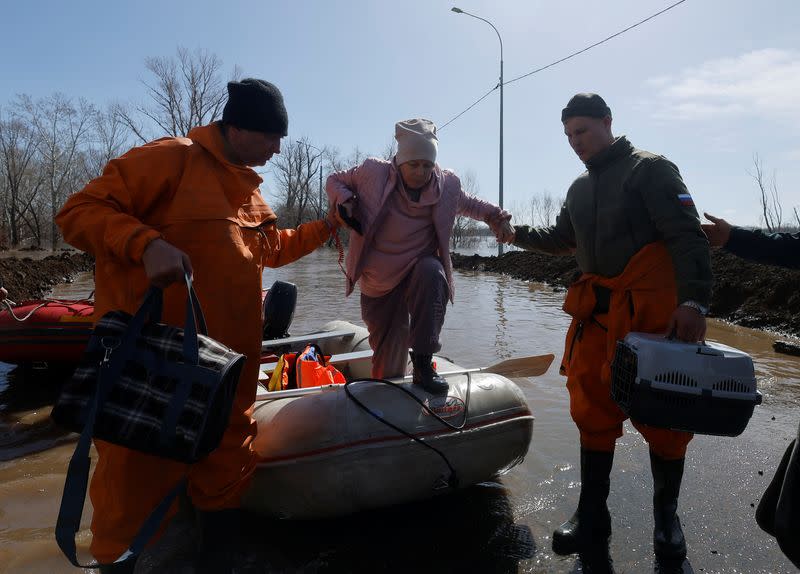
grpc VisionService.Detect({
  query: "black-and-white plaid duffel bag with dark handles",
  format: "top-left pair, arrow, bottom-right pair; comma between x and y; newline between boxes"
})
51,277 -> 245,463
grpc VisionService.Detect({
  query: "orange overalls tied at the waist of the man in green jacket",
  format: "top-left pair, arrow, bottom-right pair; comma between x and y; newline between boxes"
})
561,242 -> 693,460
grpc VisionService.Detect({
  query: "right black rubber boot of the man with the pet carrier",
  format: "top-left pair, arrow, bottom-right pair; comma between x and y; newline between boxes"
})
650,451 -> 686,562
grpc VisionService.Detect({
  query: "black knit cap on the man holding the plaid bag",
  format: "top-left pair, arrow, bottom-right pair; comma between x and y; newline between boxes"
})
222,78 -> 289,136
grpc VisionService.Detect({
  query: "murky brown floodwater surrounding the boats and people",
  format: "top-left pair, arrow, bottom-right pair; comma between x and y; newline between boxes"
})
0,250 -> 800,574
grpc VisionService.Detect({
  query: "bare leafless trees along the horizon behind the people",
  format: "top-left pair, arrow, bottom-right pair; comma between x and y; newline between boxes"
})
6,48 -> 784,254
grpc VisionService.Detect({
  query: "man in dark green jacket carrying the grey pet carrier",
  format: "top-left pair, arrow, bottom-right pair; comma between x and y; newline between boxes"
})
511,93 -> 712,571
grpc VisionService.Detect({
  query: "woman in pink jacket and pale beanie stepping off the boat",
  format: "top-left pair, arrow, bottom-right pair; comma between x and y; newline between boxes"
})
327,119 -> 511,394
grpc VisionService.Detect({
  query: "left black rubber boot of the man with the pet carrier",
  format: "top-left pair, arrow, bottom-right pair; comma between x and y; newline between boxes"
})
553,448 -> 614,556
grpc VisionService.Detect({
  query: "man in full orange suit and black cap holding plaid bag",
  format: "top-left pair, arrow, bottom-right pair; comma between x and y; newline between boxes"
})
56,78 -> 338,572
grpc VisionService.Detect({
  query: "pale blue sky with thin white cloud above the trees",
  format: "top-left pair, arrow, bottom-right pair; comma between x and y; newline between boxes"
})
0,0 -> 800,225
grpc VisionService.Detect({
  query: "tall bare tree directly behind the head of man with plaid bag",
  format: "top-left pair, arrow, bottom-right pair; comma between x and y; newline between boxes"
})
117,47 -> 239,142
